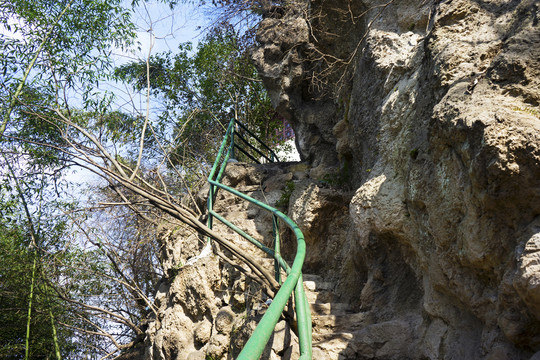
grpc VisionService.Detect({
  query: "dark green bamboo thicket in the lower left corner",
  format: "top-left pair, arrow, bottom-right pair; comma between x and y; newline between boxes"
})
0,197 -> 92,359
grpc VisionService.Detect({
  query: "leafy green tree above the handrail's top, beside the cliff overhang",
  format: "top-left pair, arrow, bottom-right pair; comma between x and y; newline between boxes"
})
116,26 -> 282,177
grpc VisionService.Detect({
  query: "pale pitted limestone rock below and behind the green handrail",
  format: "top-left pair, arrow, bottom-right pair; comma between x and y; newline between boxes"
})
145,163 -> 307,360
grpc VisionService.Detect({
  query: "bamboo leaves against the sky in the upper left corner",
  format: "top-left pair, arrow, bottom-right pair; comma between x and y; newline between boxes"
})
0,0 -> 134,90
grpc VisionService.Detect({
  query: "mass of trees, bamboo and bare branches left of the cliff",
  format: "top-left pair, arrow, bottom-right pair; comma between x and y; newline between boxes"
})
0,0 -> 281,359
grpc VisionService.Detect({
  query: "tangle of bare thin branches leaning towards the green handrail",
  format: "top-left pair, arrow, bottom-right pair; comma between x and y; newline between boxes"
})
4,90 -> 278,358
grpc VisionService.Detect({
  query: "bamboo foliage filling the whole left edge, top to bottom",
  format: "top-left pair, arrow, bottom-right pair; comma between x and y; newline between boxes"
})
0,0 -> 150,359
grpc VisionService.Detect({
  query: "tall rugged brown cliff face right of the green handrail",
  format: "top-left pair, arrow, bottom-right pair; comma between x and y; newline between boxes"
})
253,0 -> 540,359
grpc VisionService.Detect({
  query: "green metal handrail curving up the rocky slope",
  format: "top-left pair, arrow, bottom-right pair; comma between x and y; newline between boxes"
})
207,119 -> 312,360
